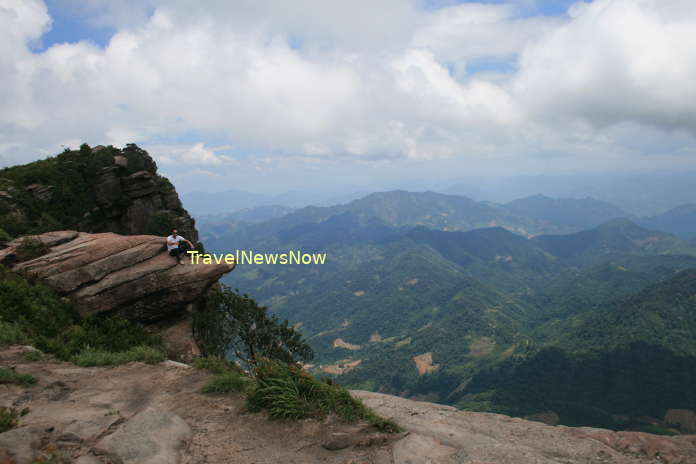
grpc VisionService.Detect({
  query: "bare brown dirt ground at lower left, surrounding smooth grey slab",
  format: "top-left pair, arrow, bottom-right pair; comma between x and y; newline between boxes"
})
0,348 -> 391,464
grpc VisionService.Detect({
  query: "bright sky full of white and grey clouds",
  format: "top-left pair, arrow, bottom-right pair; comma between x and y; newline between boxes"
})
0,0 -> 696,192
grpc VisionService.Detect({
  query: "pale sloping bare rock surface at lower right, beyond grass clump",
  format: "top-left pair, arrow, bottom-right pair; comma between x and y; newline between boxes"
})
353,391 -> 696,464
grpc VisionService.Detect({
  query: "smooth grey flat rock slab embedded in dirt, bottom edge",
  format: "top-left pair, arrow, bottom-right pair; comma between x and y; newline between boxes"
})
96,408 -> 191,464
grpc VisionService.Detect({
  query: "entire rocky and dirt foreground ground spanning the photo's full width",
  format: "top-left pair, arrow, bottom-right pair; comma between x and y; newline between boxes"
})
0,347 -> 696,464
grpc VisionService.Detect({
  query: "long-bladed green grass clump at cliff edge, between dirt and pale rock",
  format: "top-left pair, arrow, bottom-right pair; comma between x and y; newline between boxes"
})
247,359 -> 399,432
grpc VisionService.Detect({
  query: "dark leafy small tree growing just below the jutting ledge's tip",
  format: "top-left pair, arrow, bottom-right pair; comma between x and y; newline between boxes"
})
193,285 -> 314,370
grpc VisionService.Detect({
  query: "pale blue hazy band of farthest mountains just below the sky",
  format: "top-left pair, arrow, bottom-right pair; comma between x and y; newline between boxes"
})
182,171 -> 696,217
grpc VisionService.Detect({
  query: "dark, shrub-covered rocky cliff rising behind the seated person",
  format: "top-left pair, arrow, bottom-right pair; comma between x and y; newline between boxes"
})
0,144 -> 198,243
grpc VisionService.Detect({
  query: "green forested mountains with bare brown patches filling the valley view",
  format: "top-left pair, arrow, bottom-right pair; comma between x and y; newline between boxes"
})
199,191 -> 696,429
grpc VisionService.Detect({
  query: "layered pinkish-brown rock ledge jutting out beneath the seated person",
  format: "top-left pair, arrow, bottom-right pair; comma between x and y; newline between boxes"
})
0,231 -> 234,359
